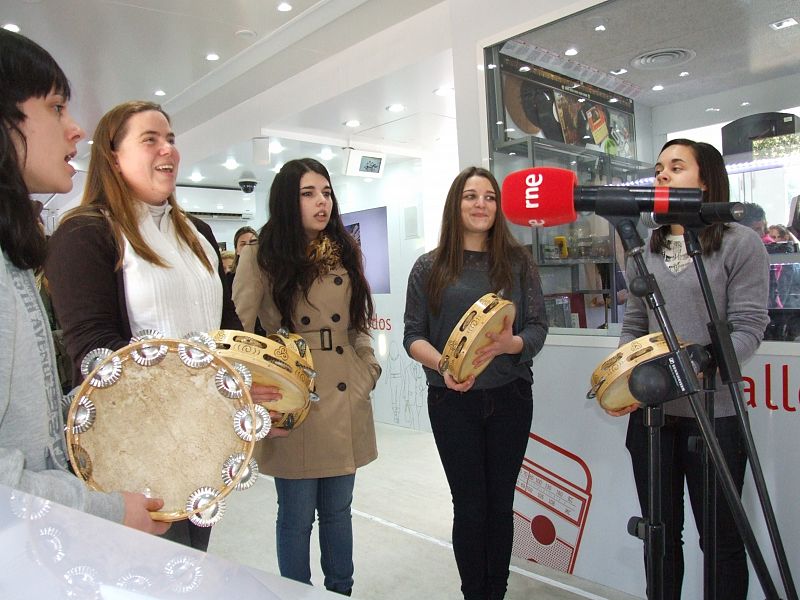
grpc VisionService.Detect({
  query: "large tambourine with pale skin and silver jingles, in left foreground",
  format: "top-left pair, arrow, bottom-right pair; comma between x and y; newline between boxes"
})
66,330 -> 270,527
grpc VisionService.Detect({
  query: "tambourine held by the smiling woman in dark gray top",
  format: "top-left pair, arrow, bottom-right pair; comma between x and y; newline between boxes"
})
439,294 -> 516,382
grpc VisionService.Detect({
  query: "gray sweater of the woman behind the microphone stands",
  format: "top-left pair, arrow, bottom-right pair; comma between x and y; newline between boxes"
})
619,223 -> 769,417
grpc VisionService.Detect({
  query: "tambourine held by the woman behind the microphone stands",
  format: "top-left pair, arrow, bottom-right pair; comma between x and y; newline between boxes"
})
586,333 -> 684,411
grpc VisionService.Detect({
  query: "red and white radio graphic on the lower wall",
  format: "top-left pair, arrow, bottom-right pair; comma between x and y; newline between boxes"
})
512,433 -> 592,573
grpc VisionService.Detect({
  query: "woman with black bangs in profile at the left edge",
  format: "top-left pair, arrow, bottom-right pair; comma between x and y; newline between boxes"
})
0,29 -> 169,534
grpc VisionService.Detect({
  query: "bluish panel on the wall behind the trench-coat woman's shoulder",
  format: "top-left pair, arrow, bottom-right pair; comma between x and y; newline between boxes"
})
342,206 -> 391,294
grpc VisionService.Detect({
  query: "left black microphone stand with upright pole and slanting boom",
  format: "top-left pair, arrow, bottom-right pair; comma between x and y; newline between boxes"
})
608,217 -> 780,600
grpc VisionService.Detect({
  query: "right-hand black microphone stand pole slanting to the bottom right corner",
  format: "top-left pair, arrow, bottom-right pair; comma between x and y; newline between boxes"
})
683,225 -> 797,600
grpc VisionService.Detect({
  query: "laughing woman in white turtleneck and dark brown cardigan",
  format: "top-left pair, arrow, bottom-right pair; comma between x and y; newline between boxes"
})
45,101 -> 241,550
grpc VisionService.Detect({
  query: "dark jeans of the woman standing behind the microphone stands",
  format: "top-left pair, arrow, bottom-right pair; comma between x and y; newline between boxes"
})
625,410 -> 748,600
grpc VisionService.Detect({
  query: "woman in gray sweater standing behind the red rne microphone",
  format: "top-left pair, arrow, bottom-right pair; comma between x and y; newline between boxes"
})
609,139 -> 769,599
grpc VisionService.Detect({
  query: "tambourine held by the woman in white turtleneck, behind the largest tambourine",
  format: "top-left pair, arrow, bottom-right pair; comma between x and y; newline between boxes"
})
210,329 -> 318,429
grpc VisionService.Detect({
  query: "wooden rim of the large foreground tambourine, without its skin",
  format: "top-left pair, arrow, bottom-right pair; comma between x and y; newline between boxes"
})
65,338 -> 260,524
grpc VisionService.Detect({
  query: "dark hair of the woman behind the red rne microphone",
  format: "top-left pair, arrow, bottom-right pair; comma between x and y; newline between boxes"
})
650,138 -> 730,254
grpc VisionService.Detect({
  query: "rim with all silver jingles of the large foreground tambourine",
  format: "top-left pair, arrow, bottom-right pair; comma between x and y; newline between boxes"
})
65,332 -> 264,527
